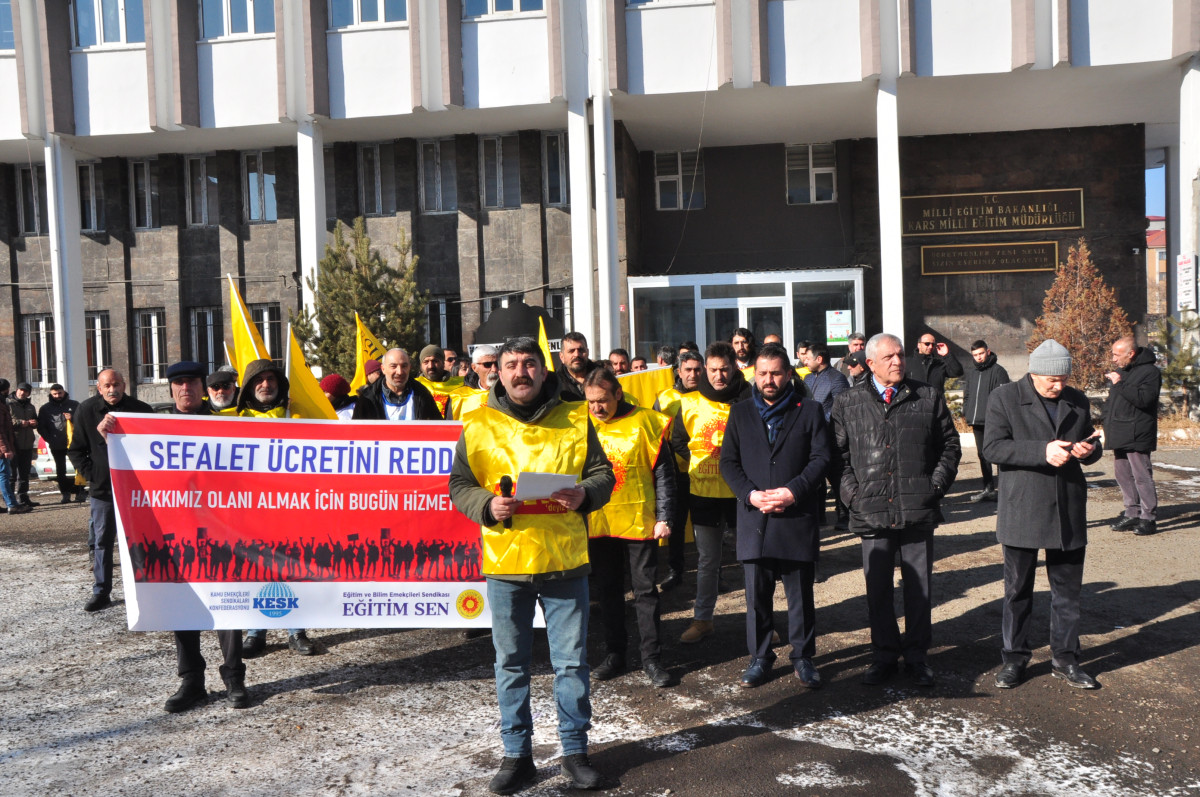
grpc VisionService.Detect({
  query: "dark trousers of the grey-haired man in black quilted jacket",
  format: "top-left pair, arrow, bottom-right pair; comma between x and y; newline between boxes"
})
863,526 -> 934,664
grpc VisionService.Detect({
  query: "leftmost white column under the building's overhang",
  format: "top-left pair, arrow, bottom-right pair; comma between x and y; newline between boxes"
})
46,133 -> 87,397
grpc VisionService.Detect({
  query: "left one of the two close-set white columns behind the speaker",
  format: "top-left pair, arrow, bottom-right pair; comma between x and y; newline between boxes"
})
563,0 -> 596,346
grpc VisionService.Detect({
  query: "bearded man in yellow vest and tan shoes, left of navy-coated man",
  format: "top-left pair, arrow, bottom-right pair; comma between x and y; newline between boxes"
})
671,341 -> 750,643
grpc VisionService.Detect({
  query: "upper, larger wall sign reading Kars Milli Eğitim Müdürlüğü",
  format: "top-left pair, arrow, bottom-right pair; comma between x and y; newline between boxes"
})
900,188 -> 1084,235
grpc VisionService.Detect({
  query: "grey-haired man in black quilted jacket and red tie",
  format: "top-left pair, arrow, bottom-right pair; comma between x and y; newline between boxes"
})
830,332 -> 962,687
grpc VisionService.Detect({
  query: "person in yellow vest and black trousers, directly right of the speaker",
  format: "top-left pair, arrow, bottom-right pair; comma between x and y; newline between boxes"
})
583,368 -> 683,688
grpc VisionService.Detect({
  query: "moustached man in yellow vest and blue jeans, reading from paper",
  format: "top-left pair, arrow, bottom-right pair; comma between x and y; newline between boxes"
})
450,337 -> 616,795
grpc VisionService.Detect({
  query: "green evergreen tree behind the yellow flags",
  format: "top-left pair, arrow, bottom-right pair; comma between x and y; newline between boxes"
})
290,216 -> 428,379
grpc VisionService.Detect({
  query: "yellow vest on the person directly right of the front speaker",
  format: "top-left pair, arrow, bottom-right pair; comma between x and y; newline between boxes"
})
588,407 -> 671,540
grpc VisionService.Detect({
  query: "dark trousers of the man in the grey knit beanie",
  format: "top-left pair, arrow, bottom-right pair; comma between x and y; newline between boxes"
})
1001,545 -> 1087,667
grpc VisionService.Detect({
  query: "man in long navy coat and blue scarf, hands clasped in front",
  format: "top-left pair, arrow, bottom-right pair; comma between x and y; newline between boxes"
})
721,343 -> 829,689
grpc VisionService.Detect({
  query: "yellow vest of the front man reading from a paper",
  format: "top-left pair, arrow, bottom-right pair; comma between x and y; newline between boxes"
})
462,402 -> 588,575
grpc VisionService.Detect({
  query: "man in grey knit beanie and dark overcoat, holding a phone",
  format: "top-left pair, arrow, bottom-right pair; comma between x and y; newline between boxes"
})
984,340 -> 1103,689
